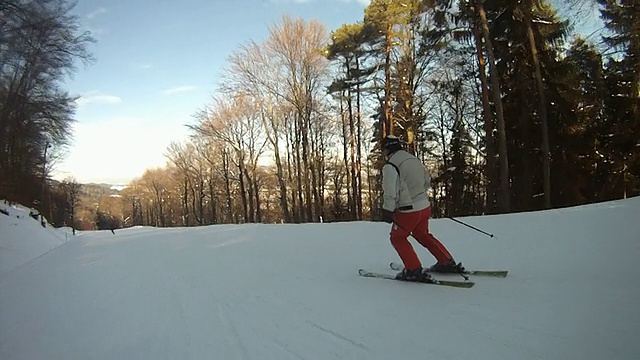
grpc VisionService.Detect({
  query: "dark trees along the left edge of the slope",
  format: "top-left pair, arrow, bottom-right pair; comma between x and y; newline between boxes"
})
0,0 -> 93,222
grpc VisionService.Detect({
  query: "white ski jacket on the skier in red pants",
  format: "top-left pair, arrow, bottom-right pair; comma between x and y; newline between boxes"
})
382,150 -> 431,212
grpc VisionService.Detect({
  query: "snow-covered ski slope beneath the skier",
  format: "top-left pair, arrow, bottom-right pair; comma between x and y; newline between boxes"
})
0,198 -> 640,360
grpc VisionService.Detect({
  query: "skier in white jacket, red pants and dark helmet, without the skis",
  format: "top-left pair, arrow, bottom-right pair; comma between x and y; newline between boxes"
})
382,135 -> 464,280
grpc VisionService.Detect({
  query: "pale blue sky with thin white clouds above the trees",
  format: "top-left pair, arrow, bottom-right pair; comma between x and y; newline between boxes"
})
52,0 -> 604,185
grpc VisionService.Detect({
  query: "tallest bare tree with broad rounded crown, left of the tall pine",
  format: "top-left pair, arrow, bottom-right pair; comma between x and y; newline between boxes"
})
225,17 -> 328,221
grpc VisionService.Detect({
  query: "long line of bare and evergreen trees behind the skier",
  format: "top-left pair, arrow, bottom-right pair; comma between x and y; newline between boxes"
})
2,0 -> 640,226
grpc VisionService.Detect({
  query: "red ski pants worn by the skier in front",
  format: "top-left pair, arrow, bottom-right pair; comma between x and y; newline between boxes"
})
391,207 -> 453,270
